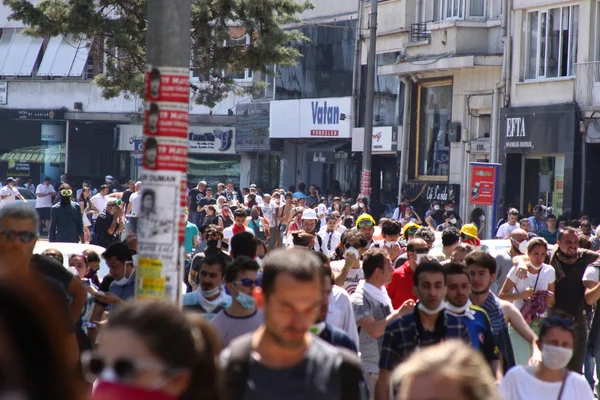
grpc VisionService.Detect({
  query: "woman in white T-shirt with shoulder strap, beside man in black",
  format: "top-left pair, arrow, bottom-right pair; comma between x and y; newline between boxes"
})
498,238 -> 556,365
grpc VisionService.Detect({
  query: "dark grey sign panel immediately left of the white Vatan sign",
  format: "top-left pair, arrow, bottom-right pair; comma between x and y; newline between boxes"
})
235,103 -> 271,152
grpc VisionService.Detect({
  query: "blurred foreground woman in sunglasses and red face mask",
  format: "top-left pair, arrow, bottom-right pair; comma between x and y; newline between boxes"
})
82,301 -> 223,400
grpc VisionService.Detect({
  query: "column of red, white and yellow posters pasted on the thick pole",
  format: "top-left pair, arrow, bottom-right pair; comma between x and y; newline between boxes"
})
136,66 -> 189,304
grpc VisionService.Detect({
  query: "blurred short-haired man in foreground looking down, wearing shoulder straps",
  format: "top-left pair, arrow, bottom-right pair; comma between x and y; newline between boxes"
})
222,249 -> 361,400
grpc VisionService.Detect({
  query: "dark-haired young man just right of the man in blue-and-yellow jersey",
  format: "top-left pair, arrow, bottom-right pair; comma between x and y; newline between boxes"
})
465,251 -> 540,372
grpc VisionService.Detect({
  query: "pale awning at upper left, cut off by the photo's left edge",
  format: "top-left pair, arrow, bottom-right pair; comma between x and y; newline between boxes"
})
0,29 -> 43,76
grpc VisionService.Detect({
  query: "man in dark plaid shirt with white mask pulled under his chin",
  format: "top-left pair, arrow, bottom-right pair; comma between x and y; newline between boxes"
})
375,261 -> 470,400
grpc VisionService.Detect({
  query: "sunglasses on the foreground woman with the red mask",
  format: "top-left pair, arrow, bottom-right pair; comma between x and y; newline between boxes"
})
81,351 -> 174,383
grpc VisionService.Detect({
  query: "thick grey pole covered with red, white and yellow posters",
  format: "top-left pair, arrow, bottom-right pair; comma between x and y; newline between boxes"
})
136,0 -> 192,305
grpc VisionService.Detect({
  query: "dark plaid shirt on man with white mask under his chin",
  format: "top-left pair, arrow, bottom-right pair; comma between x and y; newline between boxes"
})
379,308 -> 470,371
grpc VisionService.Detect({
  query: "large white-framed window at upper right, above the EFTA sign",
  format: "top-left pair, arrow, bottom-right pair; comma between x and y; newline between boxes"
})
525,6 -> 579,79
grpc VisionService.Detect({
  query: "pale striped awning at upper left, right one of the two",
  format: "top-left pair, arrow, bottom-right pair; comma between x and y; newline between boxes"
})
37,35 -> 90,76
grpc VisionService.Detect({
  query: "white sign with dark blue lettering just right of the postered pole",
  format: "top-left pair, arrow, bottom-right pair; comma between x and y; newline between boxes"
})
188,126 -> 235,154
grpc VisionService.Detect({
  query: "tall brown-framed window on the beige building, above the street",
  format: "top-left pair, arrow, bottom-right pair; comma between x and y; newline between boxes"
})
416,81 -> 452,180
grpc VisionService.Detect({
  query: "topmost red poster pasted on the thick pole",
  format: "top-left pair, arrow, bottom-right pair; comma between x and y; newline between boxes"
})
144,66 -> 190,104
